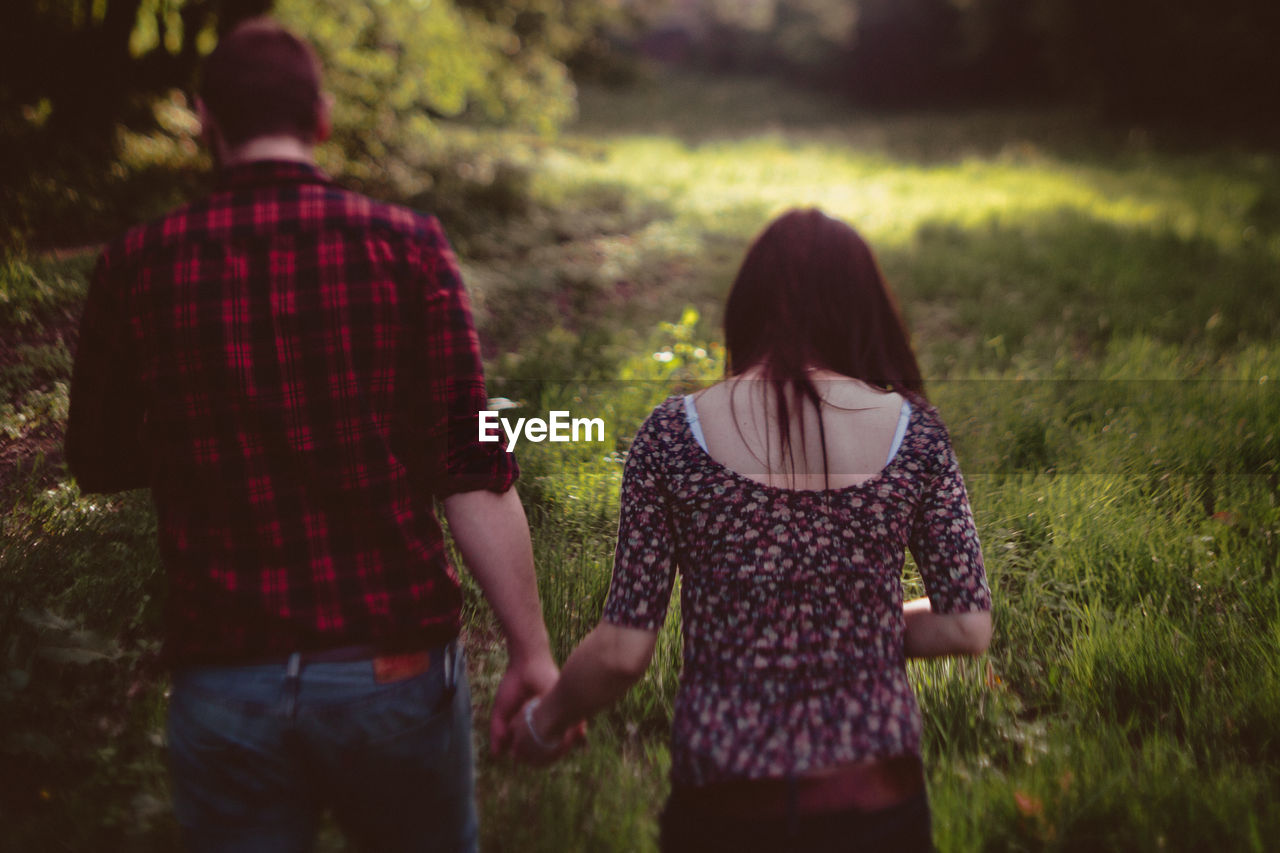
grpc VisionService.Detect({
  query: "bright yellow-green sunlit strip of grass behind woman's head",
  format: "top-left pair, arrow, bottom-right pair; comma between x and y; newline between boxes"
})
545,134 -> 1239,247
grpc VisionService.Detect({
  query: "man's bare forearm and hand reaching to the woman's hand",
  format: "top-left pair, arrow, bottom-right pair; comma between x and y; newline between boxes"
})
444,488 -> 559,754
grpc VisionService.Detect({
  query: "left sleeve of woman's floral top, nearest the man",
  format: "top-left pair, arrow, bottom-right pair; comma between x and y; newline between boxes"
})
603,414 -> 676,631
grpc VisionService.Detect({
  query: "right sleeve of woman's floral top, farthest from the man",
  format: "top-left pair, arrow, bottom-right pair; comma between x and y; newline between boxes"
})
909,429 -> 991,613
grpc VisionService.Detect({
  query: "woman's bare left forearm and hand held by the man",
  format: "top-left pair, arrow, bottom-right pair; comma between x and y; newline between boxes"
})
515,622 -> 658,761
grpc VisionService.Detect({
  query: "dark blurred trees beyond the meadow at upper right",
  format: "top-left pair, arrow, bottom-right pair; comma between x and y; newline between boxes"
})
637,0 -> 1280,126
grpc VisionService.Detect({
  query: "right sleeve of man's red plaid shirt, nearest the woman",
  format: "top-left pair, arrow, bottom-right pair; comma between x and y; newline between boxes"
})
422,219 -> 520,497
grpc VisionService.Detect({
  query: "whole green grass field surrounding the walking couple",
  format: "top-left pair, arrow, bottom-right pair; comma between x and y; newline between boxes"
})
0,79 -> 1280,852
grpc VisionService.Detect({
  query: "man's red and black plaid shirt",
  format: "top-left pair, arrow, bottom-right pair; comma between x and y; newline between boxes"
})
67,163 -> 518,663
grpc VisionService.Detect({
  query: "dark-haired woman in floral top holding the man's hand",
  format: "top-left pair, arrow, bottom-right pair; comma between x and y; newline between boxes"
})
513,210 -> 991,850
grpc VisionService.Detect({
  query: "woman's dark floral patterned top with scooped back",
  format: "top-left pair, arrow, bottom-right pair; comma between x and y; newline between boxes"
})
604,397 -> 991,785
